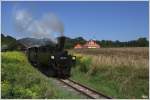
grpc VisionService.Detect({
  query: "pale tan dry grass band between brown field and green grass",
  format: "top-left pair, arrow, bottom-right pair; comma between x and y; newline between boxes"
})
91,55 -> 148,68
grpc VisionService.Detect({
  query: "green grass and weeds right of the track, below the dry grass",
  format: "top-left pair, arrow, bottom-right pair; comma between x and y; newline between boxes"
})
71,54 -> 149,98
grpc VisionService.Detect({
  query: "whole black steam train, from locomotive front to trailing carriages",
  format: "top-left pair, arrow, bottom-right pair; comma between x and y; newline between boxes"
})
27,36 -> 76,78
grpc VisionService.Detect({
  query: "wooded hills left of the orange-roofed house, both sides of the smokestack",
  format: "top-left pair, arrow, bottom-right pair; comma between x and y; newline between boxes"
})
1,34 -> 86,50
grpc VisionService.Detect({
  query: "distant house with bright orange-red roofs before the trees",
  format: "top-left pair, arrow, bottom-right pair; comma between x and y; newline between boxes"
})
74,40 -> 100,49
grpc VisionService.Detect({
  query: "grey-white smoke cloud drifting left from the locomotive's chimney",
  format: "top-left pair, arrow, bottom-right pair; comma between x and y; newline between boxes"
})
14,10 -> 64,43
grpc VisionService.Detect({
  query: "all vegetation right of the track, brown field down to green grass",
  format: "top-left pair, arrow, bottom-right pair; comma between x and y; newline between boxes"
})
71,48 -> 149,98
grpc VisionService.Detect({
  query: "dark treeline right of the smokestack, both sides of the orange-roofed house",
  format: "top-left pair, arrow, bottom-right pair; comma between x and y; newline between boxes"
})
65,37 -> 149,49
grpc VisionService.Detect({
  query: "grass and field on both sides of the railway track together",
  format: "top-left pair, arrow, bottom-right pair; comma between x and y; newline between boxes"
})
1,48 -> 149,99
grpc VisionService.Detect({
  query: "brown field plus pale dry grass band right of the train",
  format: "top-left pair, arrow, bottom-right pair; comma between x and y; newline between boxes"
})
73,48 -> 149,67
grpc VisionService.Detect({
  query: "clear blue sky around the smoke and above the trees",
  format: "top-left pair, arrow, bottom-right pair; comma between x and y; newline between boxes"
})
1,1 -> 149,41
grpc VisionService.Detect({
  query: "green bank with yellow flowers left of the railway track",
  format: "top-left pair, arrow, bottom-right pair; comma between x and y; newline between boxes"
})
1,52 -> 80,99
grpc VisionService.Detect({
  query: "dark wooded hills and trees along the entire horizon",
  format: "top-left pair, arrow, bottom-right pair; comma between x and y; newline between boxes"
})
1,34 -> 149,50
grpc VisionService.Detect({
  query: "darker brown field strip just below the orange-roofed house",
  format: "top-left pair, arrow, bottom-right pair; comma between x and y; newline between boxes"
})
72,47 -> 148,58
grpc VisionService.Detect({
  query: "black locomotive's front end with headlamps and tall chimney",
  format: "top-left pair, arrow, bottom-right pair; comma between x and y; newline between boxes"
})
50,36 -> 76,78
